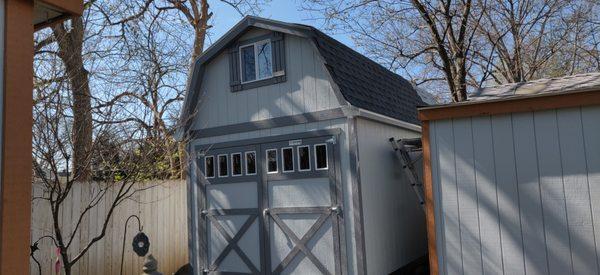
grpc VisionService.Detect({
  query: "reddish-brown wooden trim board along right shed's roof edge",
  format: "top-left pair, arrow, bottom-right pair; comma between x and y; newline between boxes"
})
419,88 -> 600,121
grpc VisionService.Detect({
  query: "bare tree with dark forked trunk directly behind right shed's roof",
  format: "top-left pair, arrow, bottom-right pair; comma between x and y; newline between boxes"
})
304,0 -> 479,101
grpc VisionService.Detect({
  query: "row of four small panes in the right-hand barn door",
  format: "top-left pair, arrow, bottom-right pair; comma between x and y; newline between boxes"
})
266,144 -> 329,174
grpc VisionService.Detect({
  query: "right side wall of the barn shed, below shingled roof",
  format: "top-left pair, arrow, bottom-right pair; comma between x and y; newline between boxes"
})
356,118 -> 427,274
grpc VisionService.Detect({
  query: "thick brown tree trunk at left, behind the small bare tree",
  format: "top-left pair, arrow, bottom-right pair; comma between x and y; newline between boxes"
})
52,17 -> 92,181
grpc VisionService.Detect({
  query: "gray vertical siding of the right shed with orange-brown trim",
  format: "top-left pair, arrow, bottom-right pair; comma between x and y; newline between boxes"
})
430,106 -> 600,274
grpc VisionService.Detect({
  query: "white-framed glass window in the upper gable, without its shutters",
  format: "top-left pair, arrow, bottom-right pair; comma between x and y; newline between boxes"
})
240,40 -> 273,83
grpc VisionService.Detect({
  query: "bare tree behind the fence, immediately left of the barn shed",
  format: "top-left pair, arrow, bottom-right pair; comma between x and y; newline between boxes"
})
94,4 -> 189,179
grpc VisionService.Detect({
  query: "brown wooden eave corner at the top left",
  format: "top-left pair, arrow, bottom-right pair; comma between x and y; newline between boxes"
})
33,0 -> 83,30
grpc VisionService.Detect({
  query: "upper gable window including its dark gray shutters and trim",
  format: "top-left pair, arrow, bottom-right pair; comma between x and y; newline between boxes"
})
229,32 -> 286,92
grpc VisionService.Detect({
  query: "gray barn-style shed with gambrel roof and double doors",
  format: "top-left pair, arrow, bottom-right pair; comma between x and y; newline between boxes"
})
182,17 -> 427,274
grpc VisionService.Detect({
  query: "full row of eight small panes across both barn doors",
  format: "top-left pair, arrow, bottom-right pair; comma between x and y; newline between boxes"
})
204,144 -> 329,178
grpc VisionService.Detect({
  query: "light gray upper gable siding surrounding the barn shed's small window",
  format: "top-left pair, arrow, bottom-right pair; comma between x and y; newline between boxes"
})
193,29 -> 340,130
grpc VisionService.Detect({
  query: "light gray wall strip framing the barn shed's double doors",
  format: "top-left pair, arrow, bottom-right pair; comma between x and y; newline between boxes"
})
188,118 -> 357,274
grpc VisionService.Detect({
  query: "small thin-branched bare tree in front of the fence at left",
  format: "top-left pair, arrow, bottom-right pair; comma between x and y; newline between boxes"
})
32,59 -> 166,274
